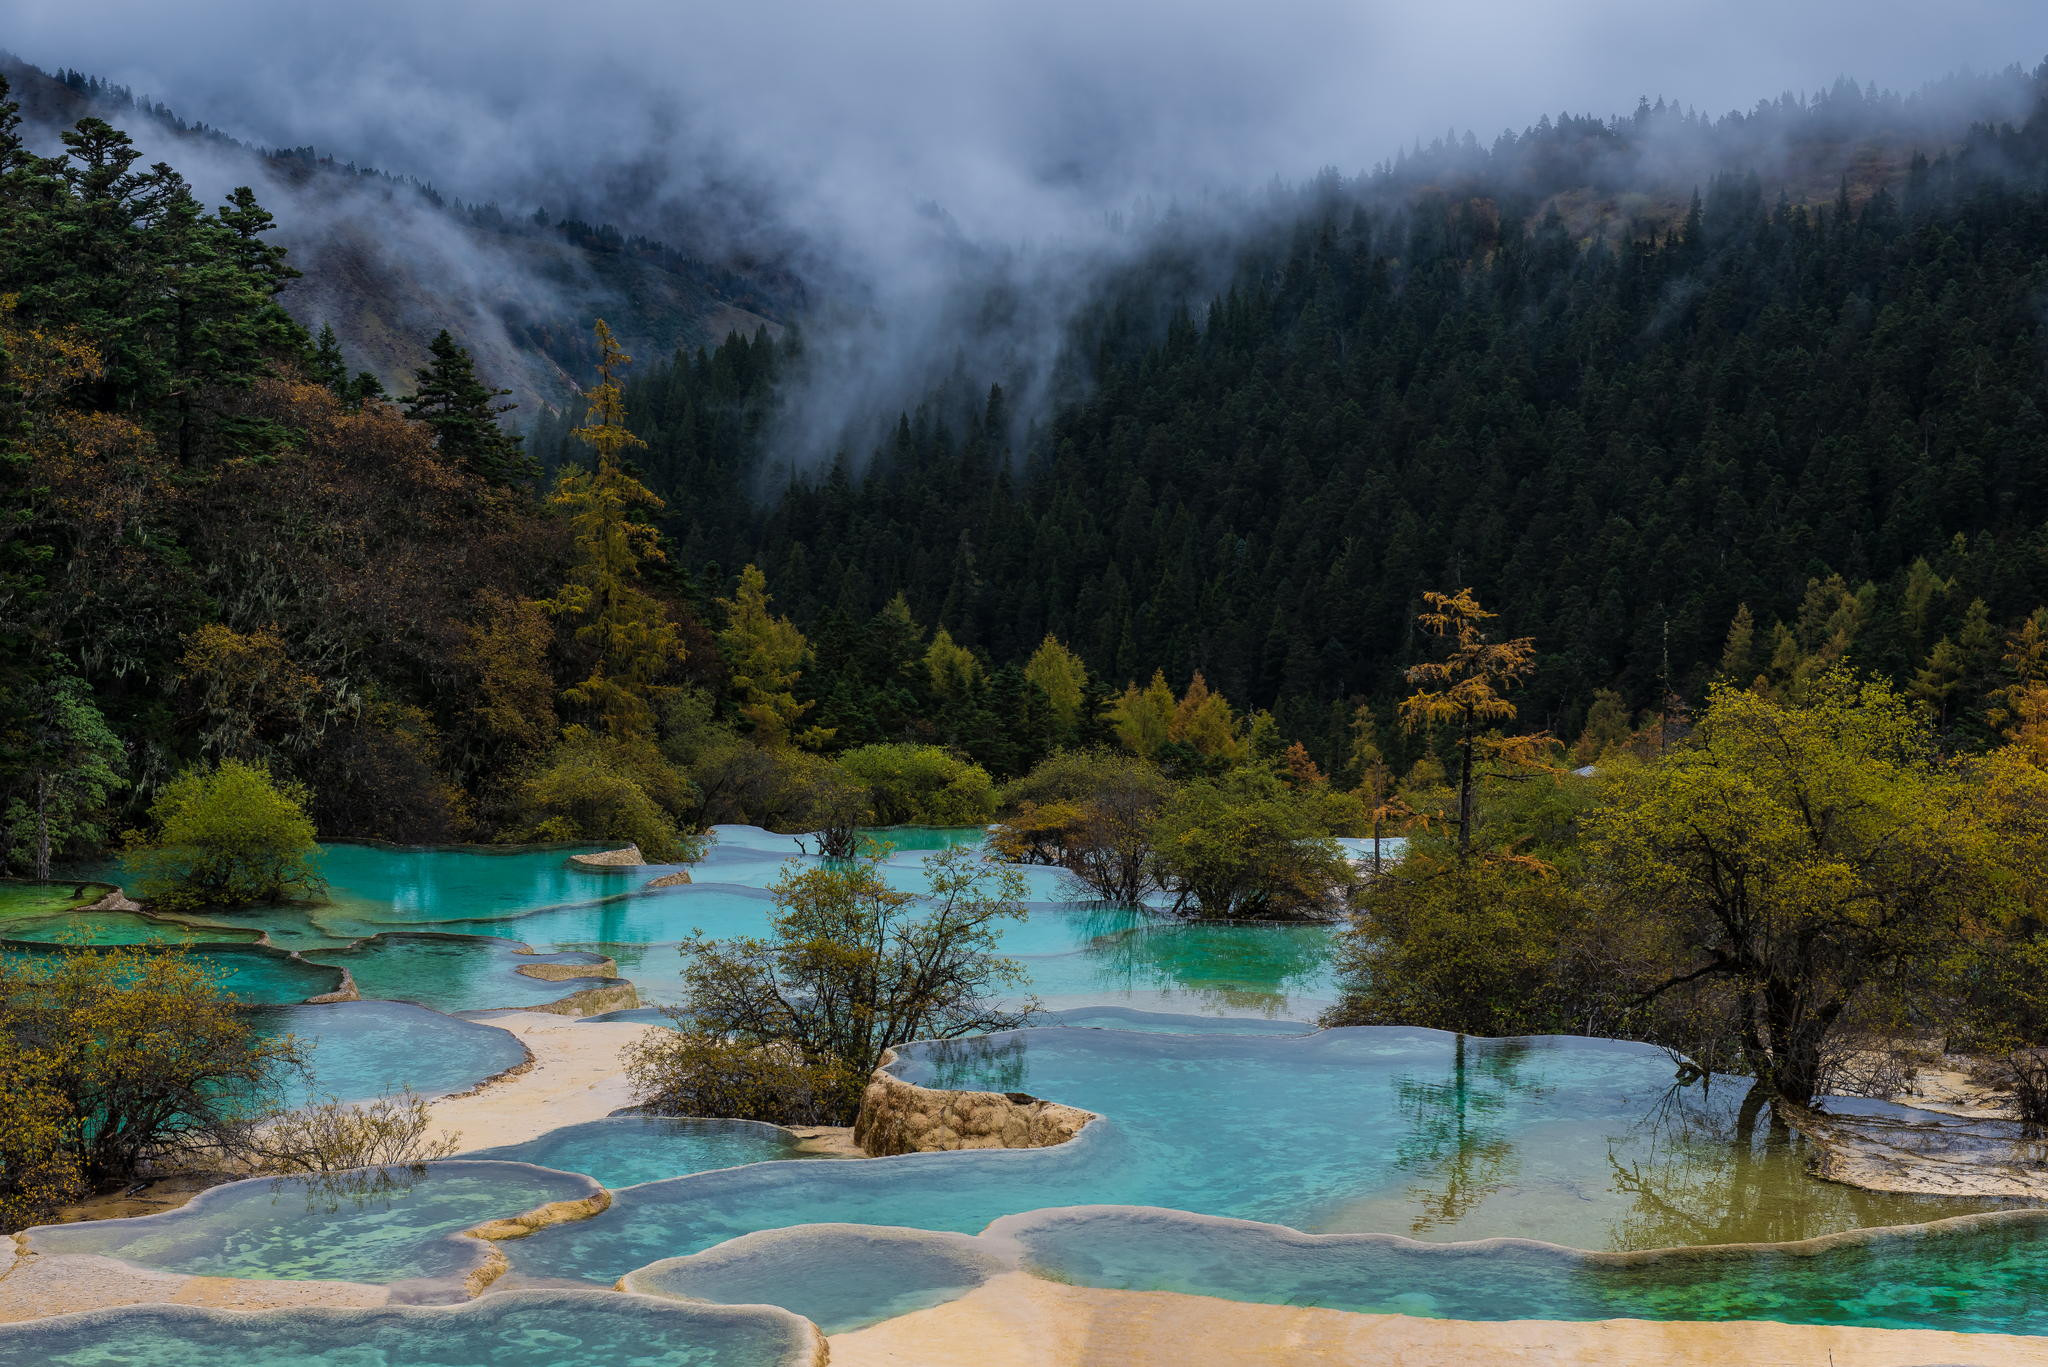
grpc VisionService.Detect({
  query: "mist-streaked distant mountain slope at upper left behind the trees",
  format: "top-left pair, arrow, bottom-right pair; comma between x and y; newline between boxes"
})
0,51 -> 803,413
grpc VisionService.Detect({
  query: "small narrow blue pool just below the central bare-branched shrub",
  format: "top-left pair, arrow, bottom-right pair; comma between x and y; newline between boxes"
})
465,1115 -> 815,1187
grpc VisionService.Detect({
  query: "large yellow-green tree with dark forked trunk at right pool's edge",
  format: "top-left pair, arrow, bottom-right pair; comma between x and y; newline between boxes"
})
1587,672 -> 1999,1105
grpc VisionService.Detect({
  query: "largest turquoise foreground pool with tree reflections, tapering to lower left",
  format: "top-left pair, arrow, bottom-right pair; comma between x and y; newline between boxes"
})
506,1029 -> 1989,1283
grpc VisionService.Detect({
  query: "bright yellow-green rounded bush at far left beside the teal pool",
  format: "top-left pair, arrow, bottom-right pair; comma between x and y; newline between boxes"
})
127,760 -> 326,910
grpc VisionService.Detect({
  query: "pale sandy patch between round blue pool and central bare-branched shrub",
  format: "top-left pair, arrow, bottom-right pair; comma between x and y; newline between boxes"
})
432,1010 -> 662,1154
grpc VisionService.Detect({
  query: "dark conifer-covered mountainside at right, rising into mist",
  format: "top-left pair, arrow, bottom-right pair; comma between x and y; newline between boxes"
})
537,68 -> 2048,762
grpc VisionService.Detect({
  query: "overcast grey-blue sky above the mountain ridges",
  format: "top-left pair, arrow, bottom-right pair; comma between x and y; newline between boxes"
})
16,0 -> 2048,234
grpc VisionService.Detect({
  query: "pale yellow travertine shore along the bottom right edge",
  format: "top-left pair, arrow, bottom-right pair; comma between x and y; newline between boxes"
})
829,1273 -> 2048,1367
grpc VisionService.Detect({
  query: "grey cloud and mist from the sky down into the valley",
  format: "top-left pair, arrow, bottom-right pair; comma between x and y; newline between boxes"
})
8,0 -> 2048,465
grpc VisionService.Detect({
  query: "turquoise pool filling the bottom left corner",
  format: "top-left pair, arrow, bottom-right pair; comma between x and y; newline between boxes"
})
0,1291 -> 815,1367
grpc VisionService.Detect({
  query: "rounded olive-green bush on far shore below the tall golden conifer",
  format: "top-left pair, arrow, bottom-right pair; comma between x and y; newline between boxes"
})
518,740 -> 705,863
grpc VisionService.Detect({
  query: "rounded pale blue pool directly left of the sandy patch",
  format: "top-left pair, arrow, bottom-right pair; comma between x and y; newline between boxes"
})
256,1002 -> 526,1107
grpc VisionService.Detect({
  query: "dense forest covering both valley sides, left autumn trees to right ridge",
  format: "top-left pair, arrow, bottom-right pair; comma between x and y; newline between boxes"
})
12,56 -> 2048,869
